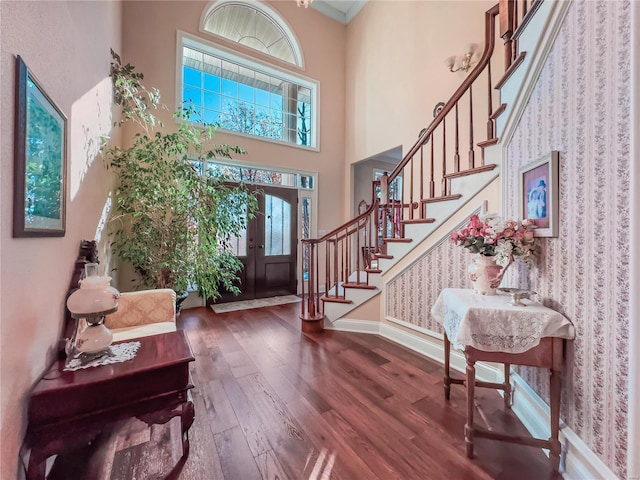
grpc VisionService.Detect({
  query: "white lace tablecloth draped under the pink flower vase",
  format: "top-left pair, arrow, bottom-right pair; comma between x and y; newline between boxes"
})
431,288 -> 575,353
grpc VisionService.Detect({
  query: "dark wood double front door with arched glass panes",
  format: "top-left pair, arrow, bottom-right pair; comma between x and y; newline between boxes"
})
217,185 -> 298,303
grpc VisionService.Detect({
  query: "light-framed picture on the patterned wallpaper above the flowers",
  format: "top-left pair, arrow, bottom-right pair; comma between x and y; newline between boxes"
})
519,152 -> 560,237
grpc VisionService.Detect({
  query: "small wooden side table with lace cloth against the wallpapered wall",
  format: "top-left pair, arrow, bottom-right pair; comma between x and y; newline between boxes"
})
431,288 -> 575,471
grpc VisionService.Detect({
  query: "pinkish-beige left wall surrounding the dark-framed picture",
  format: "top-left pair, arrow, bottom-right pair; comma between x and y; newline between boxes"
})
0,0 -> 120,480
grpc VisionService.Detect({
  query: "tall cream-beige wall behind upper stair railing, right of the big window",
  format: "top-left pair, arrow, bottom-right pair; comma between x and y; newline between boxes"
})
345,1 -> 495,171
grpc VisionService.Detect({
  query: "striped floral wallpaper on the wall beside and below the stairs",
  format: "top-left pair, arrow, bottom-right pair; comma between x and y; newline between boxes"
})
387,0 -> 632,478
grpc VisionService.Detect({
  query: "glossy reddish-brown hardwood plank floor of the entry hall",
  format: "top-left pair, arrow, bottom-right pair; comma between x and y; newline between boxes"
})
50,305 -> 559,480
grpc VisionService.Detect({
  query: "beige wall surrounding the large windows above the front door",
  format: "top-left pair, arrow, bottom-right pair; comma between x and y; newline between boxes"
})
121,1 -> 345,237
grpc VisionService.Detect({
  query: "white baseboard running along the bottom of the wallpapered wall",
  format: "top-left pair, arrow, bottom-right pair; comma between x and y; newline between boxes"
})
326,319 -> 618,480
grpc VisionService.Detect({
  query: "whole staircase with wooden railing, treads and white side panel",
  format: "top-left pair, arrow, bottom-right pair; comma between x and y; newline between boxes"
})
300,0 -> 542,332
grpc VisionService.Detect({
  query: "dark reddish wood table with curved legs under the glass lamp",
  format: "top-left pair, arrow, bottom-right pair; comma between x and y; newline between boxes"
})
25,331 -> 195,479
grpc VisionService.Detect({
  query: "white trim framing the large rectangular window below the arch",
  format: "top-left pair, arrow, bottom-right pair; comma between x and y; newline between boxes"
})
175,30 -> 320,152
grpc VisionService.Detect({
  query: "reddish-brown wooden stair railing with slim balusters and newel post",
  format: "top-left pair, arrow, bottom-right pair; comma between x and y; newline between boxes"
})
300,0 -> 542,333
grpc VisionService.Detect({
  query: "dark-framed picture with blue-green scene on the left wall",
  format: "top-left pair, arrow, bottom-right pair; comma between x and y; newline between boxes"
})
13,56 -> 67,237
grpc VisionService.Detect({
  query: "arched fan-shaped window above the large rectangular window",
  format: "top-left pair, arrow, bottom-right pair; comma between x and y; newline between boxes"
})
200,0 -> 304,67
